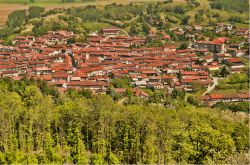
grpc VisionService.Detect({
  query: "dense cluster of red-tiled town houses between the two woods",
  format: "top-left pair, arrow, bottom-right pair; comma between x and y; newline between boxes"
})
0,28 -> 249,100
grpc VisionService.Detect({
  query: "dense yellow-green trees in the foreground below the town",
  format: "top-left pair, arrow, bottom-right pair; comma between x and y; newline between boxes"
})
0,79 -> 249,164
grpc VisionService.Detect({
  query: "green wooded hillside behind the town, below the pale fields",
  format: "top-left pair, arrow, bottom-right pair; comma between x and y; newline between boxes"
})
0,0 -> 248,43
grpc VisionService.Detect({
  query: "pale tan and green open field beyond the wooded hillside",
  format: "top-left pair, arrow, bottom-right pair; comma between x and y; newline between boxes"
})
0,0 -> 162,26
